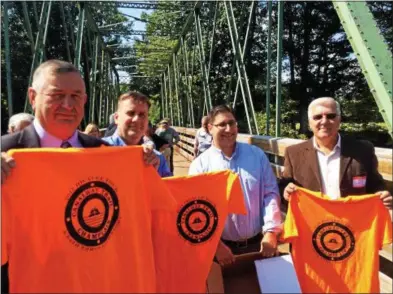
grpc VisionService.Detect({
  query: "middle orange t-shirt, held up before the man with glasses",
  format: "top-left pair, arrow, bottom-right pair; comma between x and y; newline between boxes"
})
153,171 -> 246,293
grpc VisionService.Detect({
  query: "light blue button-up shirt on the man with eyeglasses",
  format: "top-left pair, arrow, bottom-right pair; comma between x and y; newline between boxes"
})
189,142 -> 282,241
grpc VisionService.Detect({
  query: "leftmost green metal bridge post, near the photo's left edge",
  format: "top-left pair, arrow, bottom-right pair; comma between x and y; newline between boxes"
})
3,1 -> 14,117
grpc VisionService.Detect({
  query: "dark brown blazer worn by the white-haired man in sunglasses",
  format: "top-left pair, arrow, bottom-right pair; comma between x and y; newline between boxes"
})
283,136 -> 386,197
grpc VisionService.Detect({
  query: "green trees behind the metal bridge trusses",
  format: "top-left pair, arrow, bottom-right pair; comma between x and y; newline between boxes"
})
1,0 -> 393,146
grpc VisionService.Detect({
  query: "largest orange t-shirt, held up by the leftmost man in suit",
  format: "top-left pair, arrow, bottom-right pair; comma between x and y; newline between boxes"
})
2,147 -> 176,293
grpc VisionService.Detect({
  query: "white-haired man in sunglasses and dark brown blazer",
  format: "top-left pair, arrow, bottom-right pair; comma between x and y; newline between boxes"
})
283,97 -> 392,208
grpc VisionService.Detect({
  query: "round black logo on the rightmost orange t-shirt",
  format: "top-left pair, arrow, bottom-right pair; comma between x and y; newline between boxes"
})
312,222 -> 355,261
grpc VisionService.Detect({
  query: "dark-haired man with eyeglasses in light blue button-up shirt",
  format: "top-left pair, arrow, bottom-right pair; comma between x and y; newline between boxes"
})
189,105 -> 282,265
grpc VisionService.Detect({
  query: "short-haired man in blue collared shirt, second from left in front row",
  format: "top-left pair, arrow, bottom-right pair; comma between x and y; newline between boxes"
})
103,91 -> 172,177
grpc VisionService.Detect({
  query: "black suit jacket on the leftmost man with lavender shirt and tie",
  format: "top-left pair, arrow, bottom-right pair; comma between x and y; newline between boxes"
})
1,124 -> 109,293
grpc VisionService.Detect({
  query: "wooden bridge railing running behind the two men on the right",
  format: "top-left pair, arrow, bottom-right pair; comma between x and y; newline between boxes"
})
174,127 -> 393,289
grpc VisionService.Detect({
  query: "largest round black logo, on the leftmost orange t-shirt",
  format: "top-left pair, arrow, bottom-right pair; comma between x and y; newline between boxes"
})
64,181 -> 119,247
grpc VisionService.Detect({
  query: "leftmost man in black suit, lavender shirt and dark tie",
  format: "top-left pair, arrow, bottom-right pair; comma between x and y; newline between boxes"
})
1,60 -> 159,293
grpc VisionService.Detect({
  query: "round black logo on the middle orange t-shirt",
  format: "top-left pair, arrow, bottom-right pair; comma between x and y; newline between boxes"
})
177,200 -> 218,244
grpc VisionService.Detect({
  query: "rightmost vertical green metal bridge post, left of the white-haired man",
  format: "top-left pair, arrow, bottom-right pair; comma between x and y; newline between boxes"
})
276,1 -> 284,137
